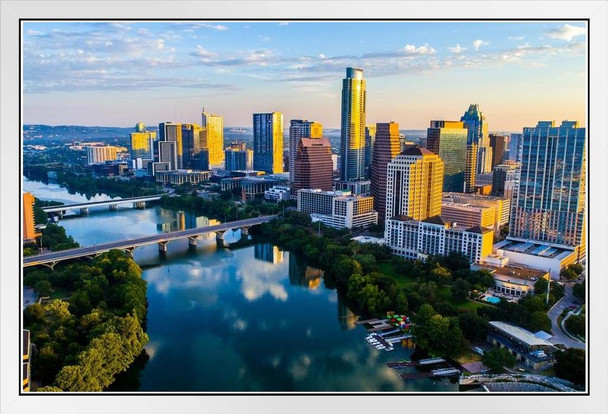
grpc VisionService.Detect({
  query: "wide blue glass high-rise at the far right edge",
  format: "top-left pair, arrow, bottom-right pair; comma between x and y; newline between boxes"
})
509,121 -> 586,260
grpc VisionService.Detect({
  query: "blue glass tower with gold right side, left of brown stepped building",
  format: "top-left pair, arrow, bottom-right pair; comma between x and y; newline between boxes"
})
253,112 -> 283,174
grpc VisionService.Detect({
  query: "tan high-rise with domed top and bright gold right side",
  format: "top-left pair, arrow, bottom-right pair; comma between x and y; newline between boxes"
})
386,146 -> 444,220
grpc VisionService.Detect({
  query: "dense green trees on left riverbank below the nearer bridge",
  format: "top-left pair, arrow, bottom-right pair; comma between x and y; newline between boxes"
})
24,250 -> 148,391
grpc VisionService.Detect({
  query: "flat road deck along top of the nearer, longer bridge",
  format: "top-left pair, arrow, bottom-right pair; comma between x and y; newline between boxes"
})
23,215 -> 277,267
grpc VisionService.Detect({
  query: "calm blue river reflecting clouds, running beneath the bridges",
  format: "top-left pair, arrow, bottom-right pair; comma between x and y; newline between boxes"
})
24,179 -> 458,392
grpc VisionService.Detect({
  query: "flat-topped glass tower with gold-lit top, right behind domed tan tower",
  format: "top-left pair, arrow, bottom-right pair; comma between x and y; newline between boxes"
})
426,121 -> 469,192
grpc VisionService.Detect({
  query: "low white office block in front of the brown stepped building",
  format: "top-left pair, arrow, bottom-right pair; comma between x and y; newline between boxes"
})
298,189 -> 378,229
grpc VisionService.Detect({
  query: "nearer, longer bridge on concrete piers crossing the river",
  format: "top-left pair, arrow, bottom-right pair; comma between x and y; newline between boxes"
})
23,215 -> 278,269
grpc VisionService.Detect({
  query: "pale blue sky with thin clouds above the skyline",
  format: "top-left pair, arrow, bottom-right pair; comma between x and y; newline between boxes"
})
22,21 -> 587,131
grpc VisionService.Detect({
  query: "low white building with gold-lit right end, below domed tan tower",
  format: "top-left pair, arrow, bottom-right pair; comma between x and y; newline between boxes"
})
384,215 -> 493,263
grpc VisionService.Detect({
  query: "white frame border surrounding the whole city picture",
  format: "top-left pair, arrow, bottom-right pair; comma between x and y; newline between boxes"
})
0,0 -> 608,414
